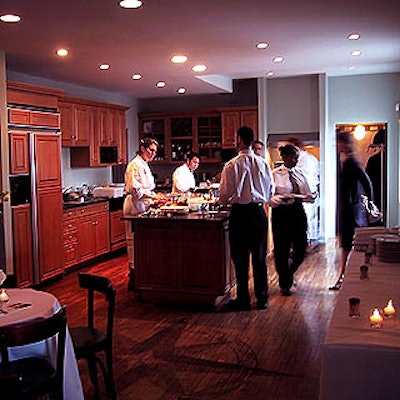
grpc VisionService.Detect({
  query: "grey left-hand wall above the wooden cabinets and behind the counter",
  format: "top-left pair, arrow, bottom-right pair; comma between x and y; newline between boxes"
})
7,71 -> 138,187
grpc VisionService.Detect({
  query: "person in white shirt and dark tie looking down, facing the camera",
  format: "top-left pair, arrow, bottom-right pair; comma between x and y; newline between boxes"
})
269,144 -> 314,296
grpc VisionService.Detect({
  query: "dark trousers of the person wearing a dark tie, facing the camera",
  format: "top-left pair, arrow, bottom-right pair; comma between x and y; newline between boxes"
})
272,202 -> 307,289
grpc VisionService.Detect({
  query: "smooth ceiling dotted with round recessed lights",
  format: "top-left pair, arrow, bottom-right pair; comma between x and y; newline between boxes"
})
0,0 -> 400,98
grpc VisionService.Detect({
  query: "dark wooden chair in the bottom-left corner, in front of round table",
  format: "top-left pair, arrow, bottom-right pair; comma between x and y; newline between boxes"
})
0,306 -> 67,400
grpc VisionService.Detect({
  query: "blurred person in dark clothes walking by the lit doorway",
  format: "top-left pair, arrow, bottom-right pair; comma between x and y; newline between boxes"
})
329,132 -> 374,290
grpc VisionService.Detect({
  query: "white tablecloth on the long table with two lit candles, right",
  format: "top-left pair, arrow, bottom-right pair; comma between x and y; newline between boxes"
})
320,251 -> 400,400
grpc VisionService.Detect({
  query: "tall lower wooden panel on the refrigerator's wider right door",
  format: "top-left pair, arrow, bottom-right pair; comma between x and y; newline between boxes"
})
37,186 -> 63,282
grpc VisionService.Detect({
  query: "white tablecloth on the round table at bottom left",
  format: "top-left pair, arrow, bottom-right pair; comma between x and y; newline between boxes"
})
0,289 -> 84,400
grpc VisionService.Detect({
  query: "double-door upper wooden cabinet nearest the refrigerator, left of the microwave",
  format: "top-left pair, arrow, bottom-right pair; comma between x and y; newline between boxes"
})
59,101 -> 92,147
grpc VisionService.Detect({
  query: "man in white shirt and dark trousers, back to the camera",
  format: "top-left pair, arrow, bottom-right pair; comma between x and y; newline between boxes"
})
219,126 -> 274,311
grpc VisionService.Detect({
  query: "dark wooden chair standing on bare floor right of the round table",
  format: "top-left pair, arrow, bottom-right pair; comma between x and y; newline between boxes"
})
69,273 -> 116,399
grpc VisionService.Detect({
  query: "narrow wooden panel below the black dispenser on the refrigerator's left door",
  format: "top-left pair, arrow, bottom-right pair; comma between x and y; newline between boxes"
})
12,204 -> 33,287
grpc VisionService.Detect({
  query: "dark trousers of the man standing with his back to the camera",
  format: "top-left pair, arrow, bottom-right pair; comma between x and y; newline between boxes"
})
229,203 -> 268,304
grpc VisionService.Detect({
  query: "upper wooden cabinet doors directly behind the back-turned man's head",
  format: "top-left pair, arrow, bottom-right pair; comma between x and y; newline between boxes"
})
221,107 -> 258,149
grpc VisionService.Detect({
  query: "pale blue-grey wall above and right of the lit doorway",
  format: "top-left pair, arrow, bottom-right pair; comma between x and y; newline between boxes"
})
328,73 -> 400,226
